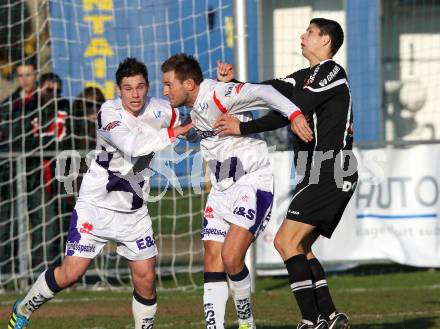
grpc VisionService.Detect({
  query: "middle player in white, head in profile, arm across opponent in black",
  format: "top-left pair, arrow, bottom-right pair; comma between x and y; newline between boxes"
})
162,54 -> 312,329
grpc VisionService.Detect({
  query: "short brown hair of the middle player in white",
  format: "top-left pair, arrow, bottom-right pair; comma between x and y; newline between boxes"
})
161,53 -> 203,85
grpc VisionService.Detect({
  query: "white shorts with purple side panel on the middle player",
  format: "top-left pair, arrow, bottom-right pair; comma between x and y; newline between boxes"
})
201,172 -> 273,243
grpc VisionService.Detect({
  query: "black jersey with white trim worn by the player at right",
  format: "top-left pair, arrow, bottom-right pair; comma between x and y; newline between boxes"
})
240,59 -> 353,171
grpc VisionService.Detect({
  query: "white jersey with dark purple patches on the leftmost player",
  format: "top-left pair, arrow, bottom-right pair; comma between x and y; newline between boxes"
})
78,97 -> 179,213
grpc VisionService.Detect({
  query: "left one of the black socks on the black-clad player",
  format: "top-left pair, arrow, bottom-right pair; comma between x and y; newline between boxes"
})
284,255 -> 319,323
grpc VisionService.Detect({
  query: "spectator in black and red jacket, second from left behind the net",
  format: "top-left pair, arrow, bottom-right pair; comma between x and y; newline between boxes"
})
26,73 -> 71,271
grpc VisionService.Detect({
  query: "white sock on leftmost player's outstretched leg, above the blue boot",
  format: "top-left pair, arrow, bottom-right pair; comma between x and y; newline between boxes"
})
17,270 -> 55,319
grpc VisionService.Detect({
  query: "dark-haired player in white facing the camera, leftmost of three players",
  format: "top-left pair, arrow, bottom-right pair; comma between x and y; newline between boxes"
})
8,58 -> 191,329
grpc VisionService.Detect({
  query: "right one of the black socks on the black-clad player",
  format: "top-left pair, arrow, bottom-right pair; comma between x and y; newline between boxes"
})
309,258 -> 336,319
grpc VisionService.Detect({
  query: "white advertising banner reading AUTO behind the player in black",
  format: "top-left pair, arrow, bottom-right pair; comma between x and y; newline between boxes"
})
256,145 -> 440,267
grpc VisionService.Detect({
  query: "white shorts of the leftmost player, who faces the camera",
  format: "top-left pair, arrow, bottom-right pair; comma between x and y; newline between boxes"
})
66,201 -> 157,260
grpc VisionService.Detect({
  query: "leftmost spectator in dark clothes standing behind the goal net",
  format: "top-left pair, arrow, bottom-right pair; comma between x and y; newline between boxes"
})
0,59 -> 37,275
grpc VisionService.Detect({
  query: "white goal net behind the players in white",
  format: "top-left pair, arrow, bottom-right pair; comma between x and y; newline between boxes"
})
0,0 -> 233,290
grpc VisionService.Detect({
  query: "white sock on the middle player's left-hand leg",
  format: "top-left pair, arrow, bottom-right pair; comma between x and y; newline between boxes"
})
203,281 -> 229,329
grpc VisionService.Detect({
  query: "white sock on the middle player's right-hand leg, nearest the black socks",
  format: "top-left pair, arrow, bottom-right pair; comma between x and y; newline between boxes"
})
229,269 -> 254,324
